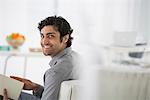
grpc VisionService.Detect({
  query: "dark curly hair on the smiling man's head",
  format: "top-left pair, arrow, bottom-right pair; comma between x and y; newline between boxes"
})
38,16 -> 73,47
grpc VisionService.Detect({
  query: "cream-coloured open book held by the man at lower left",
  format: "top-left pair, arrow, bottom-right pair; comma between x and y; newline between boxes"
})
0,74 -> 24,100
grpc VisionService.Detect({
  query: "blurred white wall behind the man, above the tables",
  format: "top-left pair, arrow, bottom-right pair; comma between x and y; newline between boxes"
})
0,0 -> 150,51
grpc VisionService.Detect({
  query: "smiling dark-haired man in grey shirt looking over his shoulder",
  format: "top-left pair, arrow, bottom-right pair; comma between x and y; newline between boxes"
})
3,16 -> 78,100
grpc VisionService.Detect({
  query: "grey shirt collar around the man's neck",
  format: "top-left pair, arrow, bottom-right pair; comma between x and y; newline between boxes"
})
49,47 -> 71,67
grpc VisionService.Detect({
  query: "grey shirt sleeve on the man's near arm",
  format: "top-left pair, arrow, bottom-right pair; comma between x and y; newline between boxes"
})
41,62 -> 70,100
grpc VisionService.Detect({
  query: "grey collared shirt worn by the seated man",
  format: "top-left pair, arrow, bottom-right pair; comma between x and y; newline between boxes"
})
34,47 -> 78,100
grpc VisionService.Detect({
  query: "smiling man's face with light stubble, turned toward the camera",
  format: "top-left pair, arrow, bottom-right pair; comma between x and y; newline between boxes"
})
41,25 -> 66,57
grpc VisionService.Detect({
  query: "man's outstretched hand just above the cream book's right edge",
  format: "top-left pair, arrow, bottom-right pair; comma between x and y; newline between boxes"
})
10,76 -> 39,91
